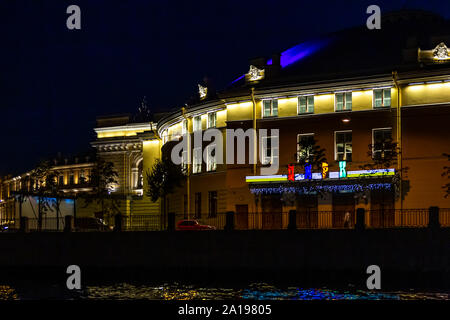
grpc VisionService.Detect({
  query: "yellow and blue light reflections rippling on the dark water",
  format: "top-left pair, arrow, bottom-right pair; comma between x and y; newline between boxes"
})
0,283 -> 450,300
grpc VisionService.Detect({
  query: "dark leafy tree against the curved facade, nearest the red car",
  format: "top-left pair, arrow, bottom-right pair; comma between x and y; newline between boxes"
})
146,156 -> 185,225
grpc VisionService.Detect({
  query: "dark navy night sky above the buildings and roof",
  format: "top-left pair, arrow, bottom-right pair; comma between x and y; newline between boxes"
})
0,0 -> 450,175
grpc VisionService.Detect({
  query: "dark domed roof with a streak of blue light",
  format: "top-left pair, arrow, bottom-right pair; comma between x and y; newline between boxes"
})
219,10 -> 450,97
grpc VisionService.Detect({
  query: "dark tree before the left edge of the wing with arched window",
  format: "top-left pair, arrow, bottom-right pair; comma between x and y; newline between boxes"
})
80,158 -> 120,221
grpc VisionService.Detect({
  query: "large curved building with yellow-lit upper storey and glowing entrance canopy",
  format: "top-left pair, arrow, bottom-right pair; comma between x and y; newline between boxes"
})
2,12 -> 450,228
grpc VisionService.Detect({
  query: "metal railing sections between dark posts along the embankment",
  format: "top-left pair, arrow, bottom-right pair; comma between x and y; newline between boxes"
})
0,208 -> 450,232
